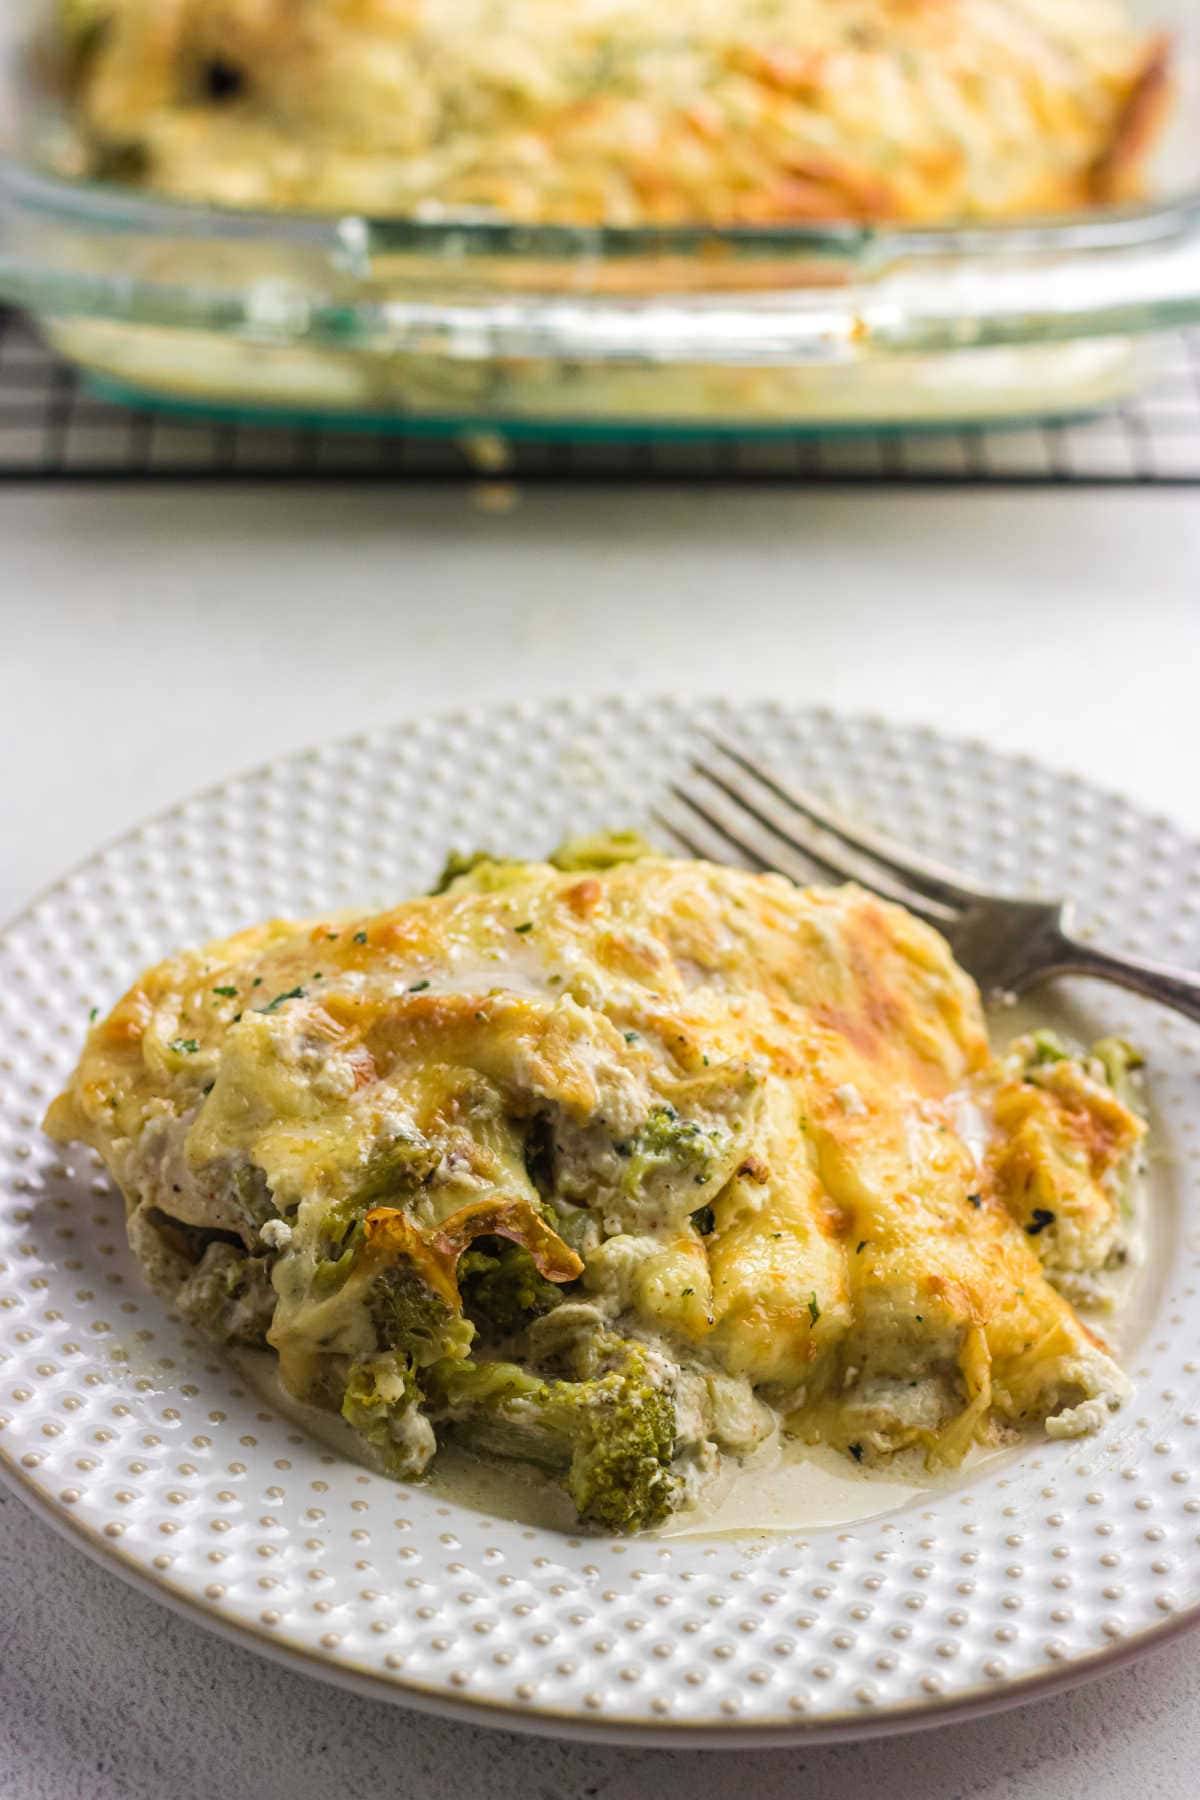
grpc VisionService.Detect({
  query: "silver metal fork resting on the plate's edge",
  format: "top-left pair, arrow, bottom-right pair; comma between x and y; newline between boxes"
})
655,734 -> 1200,1024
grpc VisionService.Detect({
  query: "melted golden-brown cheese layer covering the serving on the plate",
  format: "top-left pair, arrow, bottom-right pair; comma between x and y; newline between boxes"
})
47,857 -> 1142,1512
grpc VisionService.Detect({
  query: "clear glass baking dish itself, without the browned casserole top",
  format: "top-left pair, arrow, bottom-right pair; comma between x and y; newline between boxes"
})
0,0 -> 1200,436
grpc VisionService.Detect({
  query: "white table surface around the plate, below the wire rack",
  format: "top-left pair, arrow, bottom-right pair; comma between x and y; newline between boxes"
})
0,486 -> 1200,1800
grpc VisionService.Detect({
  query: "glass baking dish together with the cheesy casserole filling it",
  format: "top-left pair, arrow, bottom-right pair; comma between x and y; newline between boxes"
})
0,0 -> 1200,430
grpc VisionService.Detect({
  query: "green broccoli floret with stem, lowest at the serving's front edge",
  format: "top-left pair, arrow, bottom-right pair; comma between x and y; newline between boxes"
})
425,1334 -> 678,1532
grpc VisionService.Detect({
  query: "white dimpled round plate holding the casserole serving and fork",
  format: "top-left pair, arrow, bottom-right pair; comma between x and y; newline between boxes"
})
0,698 -> 1200,1744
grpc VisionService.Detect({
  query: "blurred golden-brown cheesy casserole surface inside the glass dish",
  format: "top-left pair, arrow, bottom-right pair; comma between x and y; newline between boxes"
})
63,0 -> 1168,225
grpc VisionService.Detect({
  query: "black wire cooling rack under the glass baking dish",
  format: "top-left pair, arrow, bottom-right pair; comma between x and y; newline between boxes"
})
0,310 -> 1200,486
